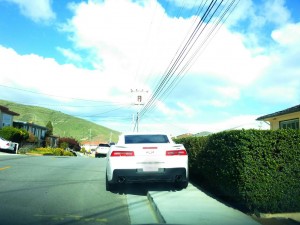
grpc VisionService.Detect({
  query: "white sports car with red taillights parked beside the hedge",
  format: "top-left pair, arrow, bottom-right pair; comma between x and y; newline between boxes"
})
106,133 -> 188,191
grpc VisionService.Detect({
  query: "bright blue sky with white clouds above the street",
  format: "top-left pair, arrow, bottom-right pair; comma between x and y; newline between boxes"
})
0,0 -> 300,135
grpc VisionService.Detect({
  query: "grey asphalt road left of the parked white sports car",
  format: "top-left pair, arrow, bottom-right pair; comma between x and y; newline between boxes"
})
0,154 -> 130,225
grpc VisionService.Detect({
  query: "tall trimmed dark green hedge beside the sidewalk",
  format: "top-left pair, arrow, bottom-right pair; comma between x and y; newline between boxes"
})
176,130 -> 300,212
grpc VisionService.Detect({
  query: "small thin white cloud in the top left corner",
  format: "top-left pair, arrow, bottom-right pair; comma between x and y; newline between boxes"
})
5,0 -> 56,22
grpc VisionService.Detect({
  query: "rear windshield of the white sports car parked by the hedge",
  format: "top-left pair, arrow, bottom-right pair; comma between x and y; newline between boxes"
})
125,134 -> 170,144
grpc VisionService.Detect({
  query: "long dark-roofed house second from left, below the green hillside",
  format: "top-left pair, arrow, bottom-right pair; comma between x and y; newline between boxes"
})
13,121 -> 48,144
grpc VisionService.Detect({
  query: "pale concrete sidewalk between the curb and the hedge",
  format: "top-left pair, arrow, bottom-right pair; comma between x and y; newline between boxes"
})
148,184 -> 260,225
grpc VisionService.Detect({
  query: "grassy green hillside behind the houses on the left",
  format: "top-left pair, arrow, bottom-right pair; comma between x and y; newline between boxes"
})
0,100 -> 119,142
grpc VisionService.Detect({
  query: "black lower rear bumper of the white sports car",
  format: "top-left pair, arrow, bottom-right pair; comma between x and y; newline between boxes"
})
110,168 -> 188,183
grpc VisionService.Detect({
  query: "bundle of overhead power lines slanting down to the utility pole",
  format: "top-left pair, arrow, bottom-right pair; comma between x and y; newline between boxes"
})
140,0 -> 239,121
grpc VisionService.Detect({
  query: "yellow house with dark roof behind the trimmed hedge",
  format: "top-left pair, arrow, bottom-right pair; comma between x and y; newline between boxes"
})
256,105 -> 300,130
